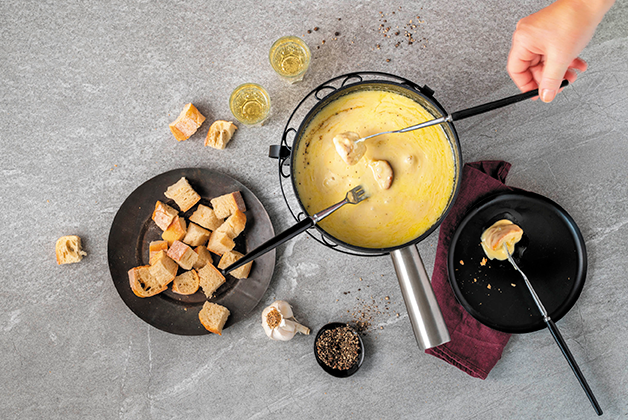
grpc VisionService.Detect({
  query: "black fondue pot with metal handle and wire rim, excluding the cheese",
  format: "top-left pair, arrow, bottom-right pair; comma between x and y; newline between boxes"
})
269,72 -> 462,349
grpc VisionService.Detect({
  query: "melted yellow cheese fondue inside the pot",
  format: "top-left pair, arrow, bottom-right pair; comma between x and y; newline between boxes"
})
293,90 -> 455,248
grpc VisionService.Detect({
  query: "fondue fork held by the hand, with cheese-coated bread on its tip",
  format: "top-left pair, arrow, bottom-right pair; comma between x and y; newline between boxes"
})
333,80 -> 569,166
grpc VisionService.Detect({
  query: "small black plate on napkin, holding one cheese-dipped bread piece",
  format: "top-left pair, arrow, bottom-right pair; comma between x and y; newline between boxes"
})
448,192 -> 587,333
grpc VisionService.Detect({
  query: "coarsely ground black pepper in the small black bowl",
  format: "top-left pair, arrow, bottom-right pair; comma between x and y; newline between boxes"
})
316,325 -> 360,370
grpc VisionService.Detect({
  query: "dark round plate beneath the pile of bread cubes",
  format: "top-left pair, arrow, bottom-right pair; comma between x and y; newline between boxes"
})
108,168 -> 275,335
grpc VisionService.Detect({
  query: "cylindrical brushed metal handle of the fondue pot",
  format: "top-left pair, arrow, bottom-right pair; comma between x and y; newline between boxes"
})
390,245 -> 450,350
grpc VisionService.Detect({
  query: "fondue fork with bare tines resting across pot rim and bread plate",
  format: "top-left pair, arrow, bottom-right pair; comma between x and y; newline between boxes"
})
220,185 -> 368,275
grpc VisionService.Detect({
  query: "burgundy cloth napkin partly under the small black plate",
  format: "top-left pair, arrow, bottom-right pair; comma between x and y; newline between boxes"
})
425,161 -> 511,379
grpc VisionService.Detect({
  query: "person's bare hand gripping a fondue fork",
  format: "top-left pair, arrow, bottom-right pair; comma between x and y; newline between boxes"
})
507,0 -> 614,102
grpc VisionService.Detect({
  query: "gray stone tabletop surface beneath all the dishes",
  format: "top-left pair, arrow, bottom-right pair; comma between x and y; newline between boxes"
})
0,0 -> 628,419
